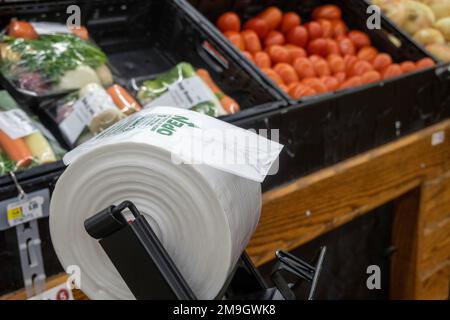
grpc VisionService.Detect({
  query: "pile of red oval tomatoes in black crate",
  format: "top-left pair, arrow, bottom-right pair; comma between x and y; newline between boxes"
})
216,5 -> 435,99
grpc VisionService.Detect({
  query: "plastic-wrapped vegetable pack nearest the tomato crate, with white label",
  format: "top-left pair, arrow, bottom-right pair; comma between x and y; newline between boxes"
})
133,62 -> 240,117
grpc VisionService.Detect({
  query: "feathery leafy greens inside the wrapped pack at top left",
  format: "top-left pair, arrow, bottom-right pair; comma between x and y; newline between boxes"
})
2,34 -> 107,82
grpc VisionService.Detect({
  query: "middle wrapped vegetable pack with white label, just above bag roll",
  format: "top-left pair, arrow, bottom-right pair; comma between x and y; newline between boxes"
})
48,83 -> 141,146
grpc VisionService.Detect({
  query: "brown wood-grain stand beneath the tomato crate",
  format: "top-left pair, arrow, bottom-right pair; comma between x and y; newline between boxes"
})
4,121 -> 450,299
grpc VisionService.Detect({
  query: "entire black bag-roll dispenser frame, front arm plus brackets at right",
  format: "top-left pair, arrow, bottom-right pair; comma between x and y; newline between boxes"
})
84,201 -> 326,300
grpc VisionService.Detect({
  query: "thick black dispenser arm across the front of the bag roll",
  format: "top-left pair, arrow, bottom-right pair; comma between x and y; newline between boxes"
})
84,201 -> 196,300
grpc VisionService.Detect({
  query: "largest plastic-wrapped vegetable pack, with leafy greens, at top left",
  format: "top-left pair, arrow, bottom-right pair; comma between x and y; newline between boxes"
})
0,21 -> 113,95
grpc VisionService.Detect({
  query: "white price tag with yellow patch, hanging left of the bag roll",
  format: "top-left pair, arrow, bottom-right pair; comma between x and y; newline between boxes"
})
6,196 -> 44,227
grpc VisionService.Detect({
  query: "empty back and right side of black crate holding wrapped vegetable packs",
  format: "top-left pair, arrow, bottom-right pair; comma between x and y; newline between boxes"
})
0,0 -> 286,121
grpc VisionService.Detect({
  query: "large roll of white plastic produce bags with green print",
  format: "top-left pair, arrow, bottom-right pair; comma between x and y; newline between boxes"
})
50,107 -> 282,299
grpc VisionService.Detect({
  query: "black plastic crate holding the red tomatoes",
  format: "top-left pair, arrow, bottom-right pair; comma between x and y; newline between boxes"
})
187,0 -> 450,190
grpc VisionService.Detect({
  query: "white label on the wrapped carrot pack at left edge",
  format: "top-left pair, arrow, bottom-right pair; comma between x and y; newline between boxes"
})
0,109 -> 37,139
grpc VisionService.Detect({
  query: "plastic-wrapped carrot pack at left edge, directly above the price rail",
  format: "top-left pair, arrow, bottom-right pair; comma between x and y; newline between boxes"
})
0,90 -> 65,175
